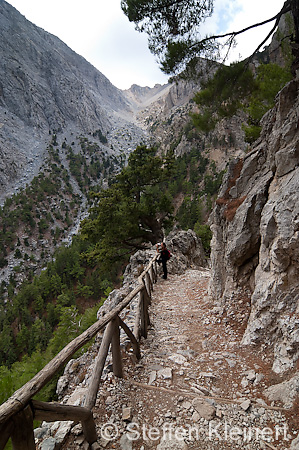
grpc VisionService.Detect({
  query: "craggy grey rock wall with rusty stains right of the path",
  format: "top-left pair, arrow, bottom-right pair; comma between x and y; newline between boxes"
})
210,80 -> 299,373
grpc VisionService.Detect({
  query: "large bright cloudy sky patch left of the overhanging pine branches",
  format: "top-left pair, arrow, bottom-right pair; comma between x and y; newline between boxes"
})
8,0 -> 168,89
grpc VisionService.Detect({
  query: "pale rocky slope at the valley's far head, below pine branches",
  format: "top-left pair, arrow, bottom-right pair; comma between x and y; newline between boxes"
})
125,60 -> 247,171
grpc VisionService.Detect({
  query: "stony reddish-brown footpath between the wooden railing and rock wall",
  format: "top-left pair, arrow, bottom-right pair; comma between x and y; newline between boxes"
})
63,269 -> 298,450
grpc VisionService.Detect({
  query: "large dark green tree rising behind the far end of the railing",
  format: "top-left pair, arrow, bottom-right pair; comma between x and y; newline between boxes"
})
81,146 -> 176,268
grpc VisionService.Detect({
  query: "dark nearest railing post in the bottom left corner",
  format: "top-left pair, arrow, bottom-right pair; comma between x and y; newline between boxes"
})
11,405 -> 35,450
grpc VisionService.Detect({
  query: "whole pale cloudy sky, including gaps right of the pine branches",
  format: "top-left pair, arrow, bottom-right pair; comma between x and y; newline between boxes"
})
6,0 -> 284,89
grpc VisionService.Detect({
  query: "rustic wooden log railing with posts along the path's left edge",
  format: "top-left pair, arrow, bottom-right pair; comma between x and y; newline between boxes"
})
0,255 -> 157,450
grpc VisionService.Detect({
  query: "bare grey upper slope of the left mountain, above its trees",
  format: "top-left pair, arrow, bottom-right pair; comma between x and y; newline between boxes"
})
0,1 -> 143,197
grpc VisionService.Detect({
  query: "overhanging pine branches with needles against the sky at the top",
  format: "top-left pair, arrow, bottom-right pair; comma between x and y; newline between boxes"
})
121,0 -> 299,77
